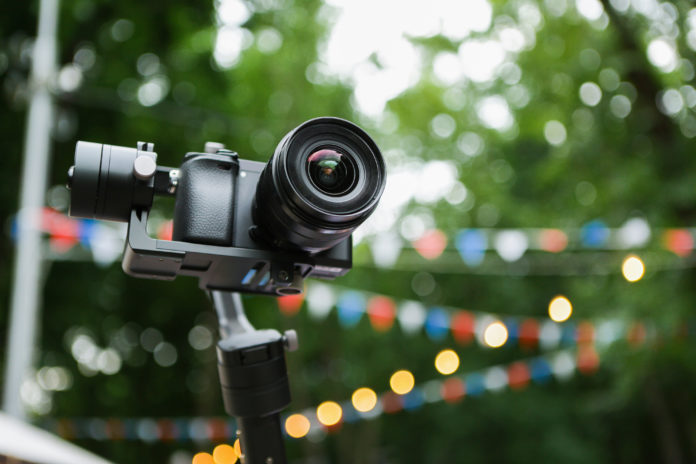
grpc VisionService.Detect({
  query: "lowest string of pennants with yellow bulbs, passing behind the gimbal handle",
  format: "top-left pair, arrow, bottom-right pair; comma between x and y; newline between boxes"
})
43,344 -> 600,443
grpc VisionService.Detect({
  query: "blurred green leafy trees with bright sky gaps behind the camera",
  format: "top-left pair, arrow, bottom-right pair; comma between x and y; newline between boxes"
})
0,0 -> 696,463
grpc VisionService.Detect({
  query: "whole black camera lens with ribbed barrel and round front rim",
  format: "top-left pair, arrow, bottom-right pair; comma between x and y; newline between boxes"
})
253,117 -> 386,253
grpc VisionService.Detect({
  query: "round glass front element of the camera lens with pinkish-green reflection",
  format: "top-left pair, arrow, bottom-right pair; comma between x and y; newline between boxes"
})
306,147 -> 357,196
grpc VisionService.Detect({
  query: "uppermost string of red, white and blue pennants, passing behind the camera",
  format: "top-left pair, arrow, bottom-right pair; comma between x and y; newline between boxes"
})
12,208 -> 696,268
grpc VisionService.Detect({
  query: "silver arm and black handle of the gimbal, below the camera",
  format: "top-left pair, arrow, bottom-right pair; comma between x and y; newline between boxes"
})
210,291 -> 297,464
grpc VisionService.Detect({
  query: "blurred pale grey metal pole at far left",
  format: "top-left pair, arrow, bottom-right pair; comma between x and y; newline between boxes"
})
3,0 -> 59,419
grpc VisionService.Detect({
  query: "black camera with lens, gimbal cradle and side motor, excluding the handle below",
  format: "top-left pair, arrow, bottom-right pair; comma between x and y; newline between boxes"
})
68,118 -> 385,295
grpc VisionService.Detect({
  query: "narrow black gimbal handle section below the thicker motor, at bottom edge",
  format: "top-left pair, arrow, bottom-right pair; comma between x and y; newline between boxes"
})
237,414 -> 287,464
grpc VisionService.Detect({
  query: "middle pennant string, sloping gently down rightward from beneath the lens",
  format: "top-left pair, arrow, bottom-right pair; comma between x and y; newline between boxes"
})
277,283 -> 664,350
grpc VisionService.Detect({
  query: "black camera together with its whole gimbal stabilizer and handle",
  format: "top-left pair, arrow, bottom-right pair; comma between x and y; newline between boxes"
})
68,118 -> 385,464
